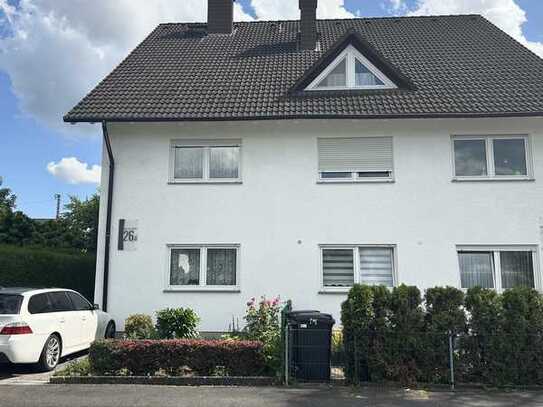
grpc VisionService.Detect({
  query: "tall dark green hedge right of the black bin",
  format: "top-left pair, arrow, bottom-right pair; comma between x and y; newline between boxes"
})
341,285 -> 543,385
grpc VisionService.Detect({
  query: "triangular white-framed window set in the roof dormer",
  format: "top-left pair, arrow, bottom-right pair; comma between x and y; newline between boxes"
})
306,45 -> 397,90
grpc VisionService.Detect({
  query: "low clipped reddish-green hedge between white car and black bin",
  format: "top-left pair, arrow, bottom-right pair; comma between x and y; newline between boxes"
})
89,339 -> 266,376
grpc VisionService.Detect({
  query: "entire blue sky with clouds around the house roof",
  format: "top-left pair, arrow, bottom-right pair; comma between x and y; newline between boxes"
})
0,0 -> 543,218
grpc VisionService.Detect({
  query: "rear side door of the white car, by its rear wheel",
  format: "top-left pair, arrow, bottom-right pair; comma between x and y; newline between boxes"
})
48,291 -> 82,355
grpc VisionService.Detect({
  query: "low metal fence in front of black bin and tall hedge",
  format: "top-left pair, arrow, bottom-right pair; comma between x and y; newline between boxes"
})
284,327 -> 543,389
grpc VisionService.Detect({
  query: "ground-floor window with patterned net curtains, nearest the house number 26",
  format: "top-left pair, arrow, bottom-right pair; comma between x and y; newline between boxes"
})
168,245 -> 239,290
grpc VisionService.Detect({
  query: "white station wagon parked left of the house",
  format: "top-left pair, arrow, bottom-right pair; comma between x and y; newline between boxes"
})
0,288 -> 115,371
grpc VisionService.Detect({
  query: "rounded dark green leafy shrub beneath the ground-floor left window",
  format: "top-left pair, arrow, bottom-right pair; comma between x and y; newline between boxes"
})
156,308 -> 200,339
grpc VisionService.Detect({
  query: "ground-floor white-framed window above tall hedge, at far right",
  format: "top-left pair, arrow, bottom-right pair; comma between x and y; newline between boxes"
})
458,247 -> 536,291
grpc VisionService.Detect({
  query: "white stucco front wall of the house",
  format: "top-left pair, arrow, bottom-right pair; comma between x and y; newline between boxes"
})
96,119 -> 543,331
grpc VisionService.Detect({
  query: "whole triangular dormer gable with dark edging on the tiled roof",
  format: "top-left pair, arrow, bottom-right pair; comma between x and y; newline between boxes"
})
291,30 -> 415,93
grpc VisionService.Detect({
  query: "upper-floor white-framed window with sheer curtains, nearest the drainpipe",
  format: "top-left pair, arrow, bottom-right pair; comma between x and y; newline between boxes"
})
171,140 -> 241,182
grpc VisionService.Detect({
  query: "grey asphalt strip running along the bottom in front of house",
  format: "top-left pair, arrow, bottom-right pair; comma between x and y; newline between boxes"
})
0,385 -> 543,407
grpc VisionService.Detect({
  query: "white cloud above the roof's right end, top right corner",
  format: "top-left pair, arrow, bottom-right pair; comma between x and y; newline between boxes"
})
408,0 -> 543,57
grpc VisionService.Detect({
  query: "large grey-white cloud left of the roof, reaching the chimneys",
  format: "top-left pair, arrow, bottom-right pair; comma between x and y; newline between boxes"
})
0,0 -> 252,132
